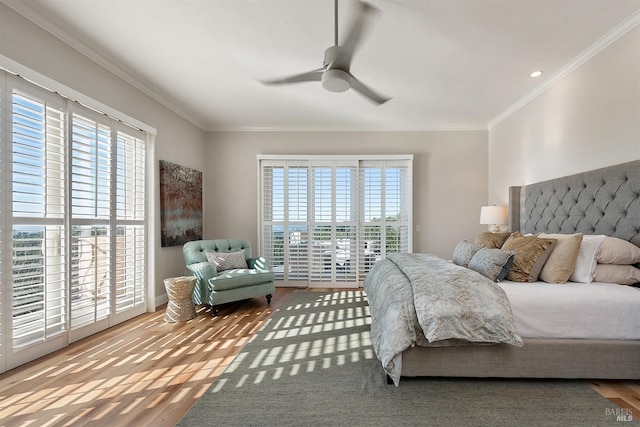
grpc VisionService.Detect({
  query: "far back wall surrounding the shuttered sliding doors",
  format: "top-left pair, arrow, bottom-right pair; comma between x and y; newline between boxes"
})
205,131 -> 488,258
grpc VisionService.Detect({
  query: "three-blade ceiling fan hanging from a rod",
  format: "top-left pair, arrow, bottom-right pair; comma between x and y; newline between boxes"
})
263,0 -> 390,105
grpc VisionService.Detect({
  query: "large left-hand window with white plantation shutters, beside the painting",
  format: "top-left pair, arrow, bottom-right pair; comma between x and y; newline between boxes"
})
0,72 -> 147,369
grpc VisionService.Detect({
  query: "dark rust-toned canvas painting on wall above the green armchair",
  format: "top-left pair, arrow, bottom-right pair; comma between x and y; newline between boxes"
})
160,160 -> 202,247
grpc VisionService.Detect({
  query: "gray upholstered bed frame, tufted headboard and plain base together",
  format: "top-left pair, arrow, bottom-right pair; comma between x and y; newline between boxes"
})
402,160 -> 640,379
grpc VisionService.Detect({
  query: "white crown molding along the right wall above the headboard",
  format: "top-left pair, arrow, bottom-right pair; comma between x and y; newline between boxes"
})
487,9 -> 640,130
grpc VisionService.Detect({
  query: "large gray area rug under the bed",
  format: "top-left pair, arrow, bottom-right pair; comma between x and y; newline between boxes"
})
178,291 -> 635,427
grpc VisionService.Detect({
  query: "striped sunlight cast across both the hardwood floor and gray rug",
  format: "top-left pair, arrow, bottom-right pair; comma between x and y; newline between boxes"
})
0,291 -> 375,427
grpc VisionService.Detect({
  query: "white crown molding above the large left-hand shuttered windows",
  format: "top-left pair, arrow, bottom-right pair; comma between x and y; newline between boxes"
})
0,0 -> 205,129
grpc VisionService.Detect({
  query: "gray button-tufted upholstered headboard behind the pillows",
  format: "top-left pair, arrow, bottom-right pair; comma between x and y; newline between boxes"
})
509,160 -> 640,246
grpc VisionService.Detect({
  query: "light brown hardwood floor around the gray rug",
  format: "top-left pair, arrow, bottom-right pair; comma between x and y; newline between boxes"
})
0,288 -> 640,427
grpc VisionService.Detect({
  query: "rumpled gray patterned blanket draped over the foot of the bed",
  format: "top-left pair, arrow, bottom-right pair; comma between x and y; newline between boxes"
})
364,254 -> 522,385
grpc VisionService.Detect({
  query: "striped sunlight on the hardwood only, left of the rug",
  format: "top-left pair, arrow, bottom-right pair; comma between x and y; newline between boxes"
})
0,311 -> 248,427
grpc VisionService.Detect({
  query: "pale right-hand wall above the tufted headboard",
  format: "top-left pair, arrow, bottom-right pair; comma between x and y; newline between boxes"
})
489,27 -> 640,204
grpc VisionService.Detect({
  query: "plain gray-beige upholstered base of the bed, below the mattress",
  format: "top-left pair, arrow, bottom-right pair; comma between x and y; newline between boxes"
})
402,338 -> 640,379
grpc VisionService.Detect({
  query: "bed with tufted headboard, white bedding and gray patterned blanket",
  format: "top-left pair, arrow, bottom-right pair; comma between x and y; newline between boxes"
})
364,160 -> 640,385
